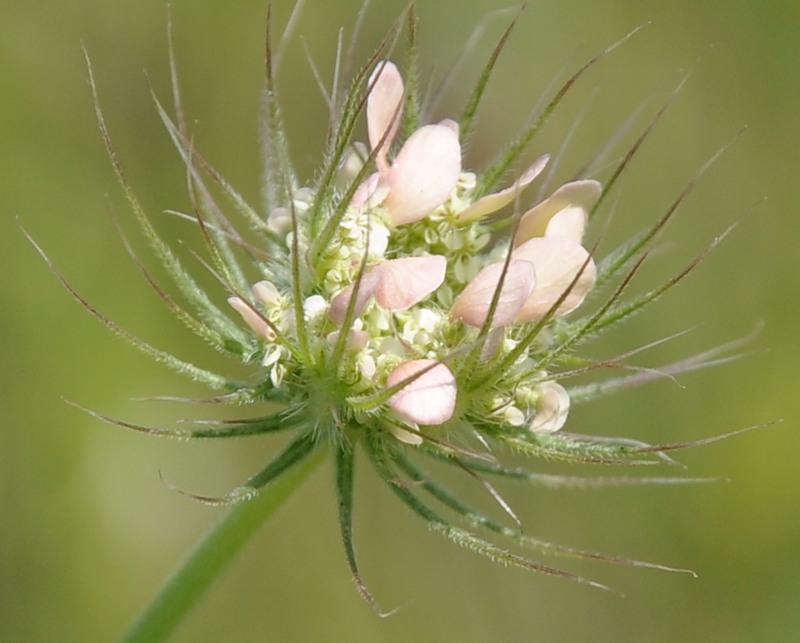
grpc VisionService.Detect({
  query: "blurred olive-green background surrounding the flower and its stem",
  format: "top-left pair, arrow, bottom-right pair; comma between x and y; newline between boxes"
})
0,0 -> 800,642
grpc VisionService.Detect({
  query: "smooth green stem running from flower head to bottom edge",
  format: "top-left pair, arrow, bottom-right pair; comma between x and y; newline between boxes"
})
120,449 -> 325,643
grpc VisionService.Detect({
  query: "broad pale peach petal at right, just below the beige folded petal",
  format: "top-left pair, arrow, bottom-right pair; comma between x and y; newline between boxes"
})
513,237 -> 597,322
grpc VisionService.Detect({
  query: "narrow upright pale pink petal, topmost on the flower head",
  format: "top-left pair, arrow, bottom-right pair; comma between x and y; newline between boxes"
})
367,60 -> 403,172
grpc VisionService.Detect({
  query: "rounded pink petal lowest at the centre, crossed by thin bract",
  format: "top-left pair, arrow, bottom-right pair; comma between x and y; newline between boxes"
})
386,359 -> 456,424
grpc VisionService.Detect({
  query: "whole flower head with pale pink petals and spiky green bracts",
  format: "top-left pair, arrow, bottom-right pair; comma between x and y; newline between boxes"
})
65,7 -> 748,605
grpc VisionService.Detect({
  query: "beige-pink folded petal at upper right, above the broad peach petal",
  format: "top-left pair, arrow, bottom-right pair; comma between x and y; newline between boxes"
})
514,179 -> 602,245
